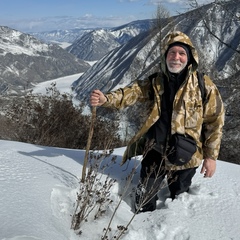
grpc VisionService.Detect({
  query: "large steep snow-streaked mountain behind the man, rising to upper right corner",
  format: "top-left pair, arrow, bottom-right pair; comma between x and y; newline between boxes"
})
73,0 -> 240,163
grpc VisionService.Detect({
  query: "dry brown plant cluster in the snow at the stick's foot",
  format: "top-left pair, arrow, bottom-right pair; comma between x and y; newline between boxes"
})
71,151 -> 115,233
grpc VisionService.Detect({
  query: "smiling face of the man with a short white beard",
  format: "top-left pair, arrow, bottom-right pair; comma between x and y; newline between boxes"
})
166,46 -> 188,73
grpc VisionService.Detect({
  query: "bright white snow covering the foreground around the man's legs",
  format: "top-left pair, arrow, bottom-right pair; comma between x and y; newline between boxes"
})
0,74 -> 240,240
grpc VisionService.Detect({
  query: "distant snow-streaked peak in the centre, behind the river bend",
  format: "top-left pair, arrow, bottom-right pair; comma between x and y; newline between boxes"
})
67,20 -> 156,61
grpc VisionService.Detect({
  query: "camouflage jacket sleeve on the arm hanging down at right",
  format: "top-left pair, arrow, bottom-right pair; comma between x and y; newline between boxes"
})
202,78 -> 224,160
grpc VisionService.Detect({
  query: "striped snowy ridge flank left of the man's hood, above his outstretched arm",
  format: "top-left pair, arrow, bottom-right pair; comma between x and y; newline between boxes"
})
73,28 -> 157,99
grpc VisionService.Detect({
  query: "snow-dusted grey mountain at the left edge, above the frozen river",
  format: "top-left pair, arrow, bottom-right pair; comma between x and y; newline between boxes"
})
0,27 -> 89,94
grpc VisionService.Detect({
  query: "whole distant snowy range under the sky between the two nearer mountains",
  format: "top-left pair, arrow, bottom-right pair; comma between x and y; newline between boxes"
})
30,19 -> 154,61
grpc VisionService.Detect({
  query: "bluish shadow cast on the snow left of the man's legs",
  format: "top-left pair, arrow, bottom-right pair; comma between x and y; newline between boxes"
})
19,146 -> 168,211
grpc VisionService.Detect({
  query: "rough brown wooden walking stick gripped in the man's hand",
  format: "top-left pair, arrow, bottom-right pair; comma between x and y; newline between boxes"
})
81,107 -> 96,183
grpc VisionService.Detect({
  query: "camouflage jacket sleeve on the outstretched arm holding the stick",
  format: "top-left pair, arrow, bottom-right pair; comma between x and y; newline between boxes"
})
102,79 -> 150,109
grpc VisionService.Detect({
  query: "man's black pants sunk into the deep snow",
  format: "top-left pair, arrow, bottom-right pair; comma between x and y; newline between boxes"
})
140,149 -> 196,200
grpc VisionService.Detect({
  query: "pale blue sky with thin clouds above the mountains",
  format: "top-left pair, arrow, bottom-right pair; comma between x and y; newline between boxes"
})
0,0 -> 210,31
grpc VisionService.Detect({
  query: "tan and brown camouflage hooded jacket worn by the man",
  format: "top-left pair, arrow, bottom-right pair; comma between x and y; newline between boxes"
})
103,32 -> 224,170
